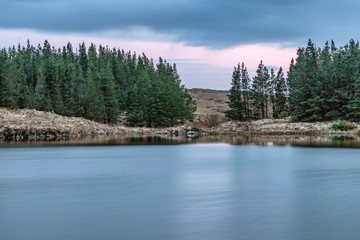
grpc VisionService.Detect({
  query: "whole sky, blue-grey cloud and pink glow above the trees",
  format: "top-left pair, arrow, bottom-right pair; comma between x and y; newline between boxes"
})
0,0 -> 360,89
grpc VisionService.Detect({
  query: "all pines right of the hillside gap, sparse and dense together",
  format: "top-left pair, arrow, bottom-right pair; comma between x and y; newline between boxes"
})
227,40 -> 360,121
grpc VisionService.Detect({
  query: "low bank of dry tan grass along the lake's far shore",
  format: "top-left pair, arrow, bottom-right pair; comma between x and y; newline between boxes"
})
0,108 -> 360,140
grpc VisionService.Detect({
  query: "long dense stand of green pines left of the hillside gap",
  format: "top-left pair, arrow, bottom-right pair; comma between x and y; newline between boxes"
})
0,41 -> 196,127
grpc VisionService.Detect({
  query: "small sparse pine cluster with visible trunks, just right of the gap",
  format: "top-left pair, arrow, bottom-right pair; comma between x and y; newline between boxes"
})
225,61 -> 288,121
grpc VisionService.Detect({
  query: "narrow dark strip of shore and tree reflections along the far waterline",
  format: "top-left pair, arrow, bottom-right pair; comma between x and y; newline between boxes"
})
2,135 -> 360,147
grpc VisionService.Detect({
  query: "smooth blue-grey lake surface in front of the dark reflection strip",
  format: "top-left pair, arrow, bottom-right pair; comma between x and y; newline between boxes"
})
0,144 -> 360,240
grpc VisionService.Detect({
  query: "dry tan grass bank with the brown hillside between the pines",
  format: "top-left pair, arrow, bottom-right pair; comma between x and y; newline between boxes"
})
0,89 -> 359,141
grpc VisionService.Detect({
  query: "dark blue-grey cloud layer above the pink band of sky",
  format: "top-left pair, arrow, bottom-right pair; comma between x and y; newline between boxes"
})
0,0 -> 360,49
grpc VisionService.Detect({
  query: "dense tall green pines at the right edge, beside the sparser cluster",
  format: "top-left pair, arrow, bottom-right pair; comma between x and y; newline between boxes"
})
288,40 -> 360,121
